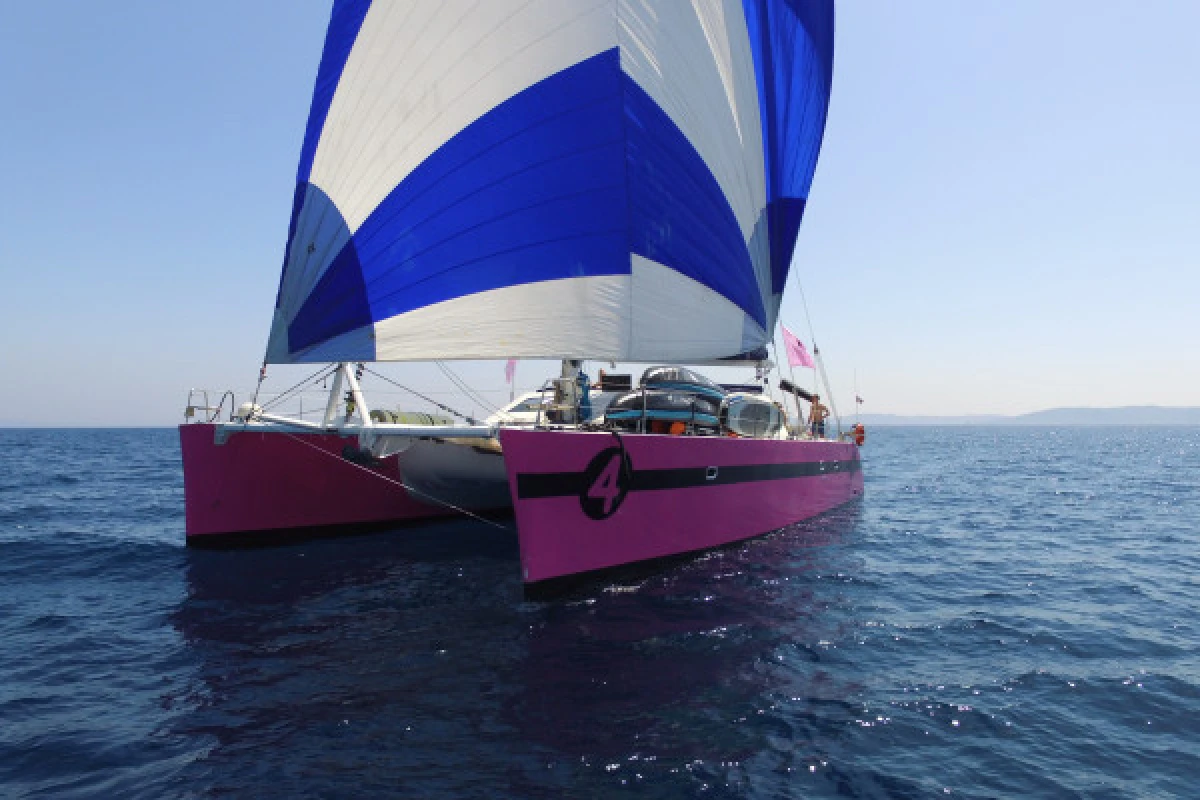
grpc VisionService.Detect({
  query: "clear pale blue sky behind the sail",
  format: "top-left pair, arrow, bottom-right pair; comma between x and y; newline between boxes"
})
0,0 -> 1200,425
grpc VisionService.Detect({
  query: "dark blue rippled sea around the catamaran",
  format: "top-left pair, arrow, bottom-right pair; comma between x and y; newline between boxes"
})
0,428 -> 1200,798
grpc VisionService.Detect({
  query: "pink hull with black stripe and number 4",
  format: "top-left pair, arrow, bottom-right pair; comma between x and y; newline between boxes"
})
500,429 -> 863,583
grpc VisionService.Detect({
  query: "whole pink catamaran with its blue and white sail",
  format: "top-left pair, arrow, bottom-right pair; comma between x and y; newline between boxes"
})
180,0 -> 863,583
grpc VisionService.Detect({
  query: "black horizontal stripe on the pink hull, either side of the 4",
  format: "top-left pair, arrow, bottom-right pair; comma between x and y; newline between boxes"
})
516,458 -> 863,500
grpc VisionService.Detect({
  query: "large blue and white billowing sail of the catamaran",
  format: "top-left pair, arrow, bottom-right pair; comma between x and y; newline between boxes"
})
268,0 -> 833,363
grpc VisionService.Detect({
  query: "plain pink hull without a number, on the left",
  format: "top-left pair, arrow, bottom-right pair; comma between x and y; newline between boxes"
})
179,425 -> 443,543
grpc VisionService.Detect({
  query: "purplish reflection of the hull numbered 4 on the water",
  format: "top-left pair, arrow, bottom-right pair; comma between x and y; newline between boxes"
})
509,517 -> 864,762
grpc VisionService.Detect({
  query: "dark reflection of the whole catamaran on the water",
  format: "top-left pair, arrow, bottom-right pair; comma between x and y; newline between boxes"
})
173,505 -> 858,796
